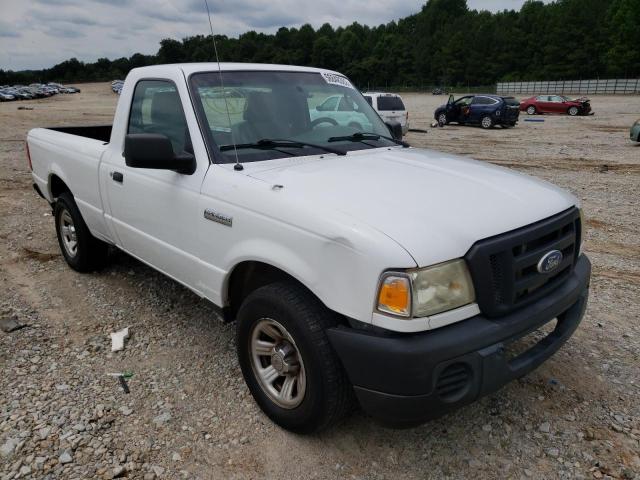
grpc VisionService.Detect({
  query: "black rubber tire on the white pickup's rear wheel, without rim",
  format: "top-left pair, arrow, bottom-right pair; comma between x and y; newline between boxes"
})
53,192 -> 109,273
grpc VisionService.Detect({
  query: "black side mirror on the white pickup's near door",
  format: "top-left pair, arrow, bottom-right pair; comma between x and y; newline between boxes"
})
124,133 -> 196,175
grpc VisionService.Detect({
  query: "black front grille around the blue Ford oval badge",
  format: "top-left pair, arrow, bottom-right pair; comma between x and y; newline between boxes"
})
465,207 -> 580,317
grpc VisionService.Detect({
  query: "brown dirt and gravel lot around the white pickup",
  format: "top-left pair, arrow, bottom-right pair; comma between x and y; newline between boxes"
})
0,84 -> 640,479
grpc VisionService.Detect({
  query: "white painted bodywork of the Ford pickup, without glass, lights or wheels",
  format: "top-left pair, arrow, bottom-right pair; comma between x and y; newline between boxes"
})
28,64 -> 577,332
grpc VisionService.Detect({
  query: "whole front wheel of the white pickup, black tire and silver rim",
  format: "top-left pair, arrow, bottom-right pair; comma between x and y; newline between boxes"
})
236,282 -> 353,433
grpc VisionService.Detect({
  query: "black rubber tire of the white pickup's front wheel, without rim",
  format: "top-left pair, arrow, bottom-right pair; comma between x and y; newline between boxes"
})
236,282 -> 354,433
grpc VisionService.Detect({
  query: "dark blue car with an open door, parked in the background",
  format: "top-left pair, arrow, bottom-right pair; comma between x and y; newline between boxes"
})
434,95 -> 520,128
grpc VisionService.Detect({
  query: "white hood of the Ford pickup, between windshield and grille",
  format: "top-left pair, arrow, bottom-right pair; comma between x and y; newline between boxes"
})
245,147 -> 577,267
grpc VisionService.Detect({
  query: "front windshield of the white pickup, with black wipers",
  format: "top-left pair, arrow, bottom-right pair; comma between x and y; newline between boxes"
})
190,71 -> 396,163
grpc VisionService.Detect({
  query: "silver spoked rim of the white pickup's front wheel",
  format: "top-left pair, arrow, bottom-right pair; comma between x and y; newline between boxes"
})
249,318 -> 307,410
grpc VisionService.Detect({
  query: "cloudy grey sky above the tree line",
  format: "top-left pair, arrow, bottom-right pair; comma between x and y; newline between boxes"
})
0,0 -> 540,70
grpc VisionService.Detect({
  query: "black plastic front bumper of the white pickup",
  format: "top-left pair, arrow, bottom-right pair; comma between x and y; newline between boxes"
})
328,255 -> 591,427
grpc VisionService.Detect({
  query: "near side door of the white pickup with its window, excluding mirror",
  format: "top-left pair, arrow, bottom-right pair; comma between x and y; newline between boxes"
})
101,79 -> 208,288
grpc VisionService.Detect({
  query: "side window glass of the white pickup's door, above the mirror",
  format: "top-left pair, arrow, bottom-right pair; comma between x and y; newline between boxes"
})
127,80 -> 192,155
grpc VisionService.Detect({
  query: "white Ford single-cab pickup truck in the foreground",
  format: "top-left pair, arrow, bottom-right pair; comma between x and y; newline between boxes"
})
27,63 -> 591,432
